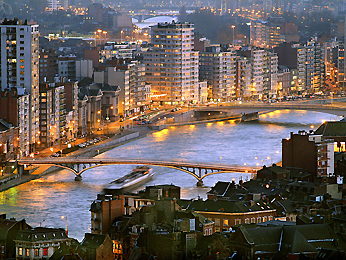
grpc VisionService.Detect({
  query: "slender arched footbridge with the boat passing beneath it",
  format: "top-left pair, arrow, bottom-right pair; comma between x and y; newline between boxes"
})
17,157 -> 260,186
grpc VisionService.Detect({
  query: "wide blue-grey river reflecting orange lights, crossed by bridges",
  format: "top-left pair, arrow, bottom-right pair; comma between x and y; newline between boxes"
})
0,110 -> 337,241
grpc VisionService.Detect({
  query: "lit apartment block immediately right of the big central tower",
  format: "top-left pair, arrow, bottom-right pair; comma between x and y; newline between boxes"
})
199,45 -> 236,102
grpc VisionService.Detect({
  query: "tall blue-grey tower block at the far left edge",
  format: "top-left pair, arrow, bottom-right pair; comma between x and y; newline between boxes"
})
0,19 -> 39,151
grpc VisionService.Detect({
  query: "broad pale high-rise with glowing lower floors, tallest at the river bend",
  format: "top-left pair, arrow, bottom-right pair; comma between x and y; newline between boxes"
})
144,23 -> 198,105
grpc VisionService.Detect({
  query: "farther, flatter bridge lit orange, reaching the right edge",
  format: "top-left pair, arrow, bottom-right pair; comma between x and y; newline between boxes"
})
198,102 -> 346,116
